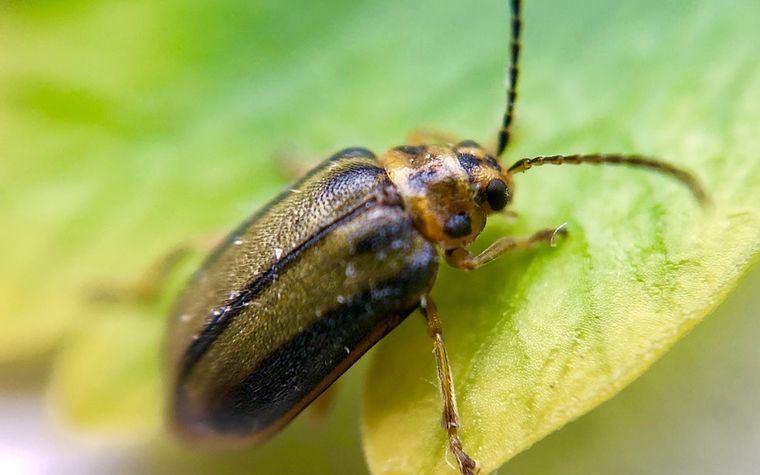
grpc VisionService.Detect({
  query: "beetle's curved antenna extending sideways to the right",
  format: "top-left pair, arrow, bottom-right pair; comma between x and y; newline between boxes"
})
507,153 -> 709,206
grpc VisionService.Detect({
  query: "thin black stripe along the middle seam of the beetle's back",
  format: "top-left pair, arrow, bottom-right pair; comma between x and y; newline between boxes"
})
179,182 -> 392,380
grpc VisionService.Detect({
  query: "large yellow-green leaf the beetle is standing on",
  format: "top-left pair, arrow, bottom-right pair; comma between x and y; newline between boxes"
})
0,0 -> 760,473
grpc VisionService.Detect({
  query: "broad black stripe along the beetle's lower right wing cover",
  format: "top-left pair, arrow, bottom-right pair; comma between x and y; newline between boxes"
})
199,244 -> 437,434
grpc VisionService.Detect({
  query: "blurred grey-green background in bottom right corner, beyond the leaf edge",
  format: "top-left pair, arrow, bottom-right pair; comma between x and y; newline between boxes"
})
504,266 -> 760,475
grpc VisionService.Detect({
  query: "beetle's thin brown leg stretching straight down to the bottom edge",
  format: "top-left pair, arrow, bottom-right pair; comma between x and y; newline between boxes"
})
420,295 -> 478,475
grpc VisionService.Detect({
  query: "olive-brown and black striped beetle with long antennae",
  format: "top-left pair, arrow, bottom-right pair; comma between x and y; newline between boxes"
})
168,0 -> 707,474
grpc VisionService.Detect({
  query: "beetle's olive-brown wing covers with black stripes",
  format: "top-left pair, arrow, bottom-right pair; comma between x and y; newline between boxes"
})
170,149 -> 437,440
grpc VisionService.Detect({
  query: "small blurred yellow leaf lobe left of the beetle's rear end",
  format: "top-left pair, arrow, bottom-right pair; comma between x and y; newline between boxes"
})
50,311 -> 163,438
